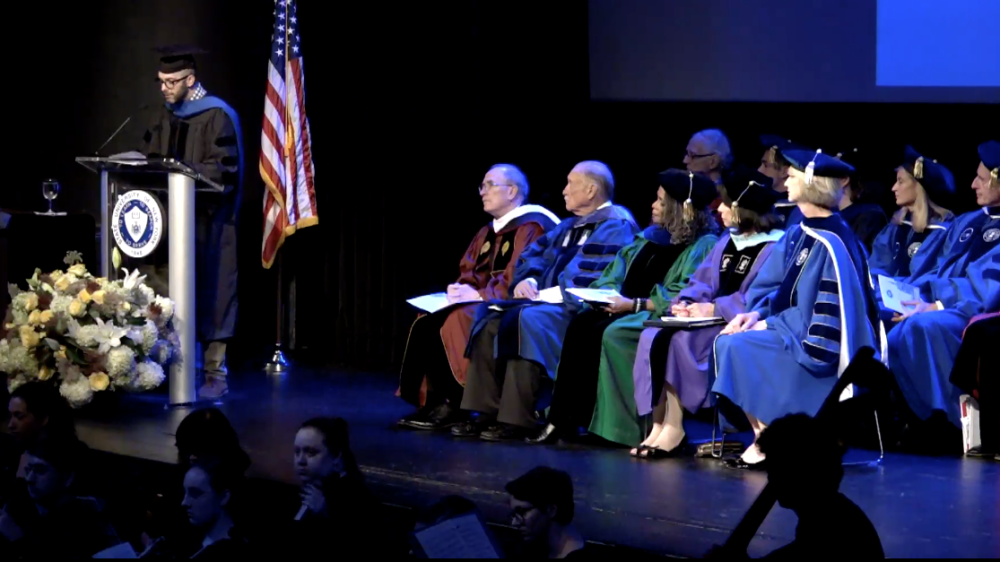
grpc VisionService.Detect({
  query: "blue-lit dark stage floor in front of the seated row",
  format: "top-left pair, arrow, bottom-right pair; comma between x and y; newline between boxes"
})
78,369 -> 1000,558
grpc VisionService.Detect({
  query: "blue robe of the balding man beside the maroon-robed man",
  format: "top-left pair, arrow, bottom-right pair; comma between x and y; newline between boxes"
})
467,205 -> 639,379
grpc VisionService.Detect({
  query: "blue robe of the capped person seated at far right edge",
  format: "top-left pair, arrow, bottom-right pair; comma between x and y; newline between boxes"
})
889,207 -> 1000,426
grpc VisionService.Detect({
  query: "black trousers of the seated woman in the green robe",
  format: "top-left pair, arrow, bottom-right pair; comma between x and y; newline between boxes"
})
549,309 -> 624,430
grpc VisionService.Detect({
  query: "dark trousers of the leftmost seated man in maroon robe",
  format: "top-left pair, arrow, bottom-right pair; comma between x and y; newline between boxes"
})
399,309 -> 463,407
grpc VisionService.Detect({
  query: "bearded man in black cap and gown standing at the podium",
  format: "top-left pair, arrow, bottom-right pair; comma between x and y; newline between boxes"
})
139,46 -> 243,400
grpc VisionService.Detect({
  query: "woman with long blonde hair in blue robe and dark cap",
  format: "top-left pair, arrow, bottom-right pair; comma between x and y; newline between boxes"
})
868,146 -> 955,320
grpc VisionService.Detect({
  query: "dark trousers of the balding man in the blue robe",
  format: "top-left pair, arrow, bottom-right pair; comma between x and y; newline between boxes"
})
462,318 -> 551,427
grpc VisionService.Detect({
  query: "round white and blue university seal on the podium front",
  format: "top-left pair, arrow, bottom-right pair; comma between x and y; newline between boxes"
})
111,190 -> 163,258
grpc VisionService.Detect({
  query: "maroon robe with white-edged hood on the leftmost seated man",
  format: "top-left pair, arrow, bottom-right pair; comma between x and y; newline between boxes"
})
396,205 -> 558,407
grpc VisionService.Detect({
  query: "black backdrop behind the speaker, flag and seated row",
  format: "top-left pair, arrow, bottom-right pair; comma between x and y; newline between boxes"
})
0,0 -> 996,369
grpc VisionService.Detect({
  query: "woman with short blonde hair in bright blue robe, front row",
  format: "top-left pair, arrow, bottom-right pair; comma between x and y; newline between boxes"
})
712,151 -> 879,468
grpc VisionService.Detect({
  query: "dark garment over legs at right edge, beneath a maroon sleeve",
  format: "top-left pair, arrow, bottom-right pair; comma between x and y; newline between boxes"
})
951,316 -> 1000,453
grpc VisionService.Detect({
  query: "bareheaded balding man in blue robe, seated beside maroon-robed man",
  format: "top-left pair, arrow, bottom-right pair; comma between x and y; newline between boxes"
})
452,161 -> 639,441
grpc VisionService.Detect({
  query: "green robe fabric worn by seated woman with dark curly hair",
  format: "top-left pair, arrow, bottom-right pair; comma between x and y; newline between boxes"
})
589,230 -> 719,447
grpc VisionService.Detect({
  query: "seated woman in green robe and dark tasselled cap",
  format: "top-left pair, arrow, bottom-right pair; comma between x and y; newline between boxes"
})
527,169 -> 719,445
